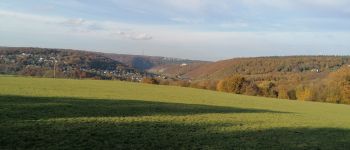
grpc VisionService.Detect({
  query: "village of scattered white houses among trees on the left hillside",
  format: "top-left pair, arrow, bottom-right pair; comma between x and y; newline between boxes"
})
0,52 -> 156,82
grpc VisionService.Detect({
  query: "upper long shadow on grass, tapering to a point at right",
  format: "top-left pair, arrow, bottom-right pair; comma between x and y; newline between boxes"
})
0,96 -> 282,120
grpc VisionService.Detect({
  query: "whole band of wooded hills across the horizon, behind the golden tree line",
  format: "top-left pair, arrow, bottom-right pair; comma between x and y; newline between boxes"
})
0,47 -> 350,80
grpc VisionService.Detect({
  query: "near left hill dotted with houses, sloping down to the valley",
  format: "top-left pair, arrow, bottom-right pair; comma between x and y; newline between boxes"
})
0,47 -> 145,80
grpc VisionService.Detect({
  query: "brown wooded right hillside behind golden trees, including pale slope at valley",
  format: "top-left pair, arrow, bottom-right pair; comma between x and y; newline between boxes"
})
130,56 -> 350,81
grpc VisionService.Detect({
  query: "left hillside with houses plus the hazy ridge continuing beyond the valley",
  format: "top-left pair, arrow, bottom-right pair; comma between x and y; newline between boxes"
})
0,47 -> 209,81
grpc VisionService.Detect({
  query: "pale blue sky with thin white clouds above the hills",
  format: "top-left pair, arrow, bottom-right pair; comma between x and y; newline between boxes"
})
0,0 -> 350,61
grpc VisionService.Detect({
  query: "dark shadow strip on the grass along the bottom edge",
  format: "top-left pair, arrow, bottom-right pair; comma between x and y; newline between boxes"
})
0,121 -> 350,150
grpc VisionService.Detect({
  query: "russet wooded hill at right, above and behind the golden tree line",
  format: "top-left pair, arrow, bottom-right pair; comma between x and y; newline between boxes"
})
183,56 -> 350,79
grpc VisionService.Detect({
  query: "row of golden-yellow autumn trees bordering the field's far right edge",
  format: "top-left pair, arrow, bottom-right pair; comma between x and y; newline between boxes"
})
142,65 -> 350,104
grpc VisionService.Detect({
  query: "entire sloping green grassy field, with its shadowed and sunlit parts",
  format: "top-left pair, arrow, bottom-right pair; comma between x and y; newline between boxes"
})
0,76 -> 350,149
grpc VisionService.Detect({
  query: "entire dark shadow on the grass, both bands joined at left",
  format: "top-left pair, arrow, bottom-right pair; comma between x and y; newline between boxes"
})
0,96 -> 350,150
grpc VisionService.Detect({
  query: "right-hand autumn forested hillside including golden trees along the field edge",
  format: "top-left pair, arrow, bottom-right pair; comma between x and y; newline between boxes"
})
163,56 -> 350,104
